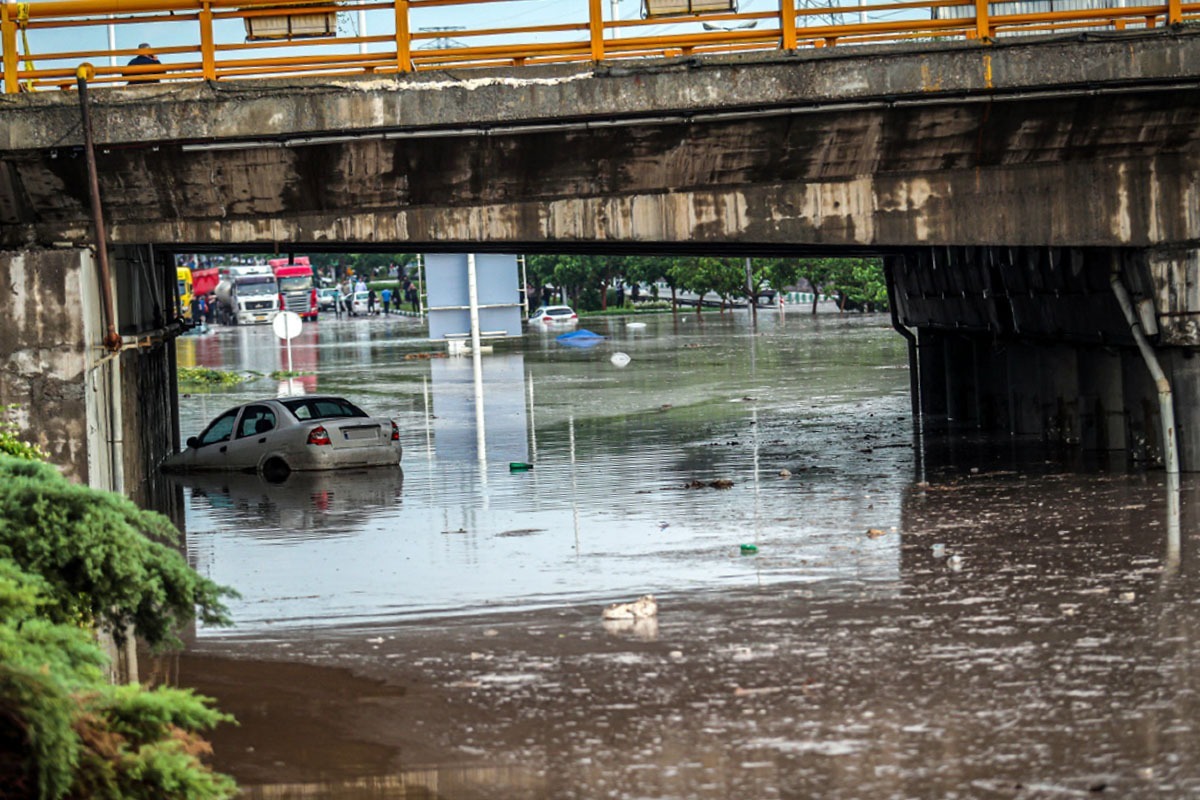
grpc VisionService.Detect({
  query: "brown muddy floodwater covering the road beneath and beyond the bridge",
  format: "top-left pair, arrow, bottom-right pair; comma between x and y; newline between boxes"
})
162,313 -> 1200,800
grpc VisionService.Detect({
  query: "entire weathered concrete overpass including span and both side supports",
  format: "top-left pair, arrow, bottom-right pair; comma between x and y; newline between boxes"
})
0,6 -> 1200,494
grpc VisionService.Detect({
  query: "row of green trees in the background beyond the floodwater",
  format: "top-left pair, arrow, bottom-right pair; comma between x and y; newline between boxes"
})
304,253 -> 888,312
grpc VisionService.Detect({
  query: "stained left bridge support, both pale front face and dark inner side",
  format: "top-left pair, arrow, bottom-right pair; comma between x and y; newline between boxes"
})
0,248 -> 182,501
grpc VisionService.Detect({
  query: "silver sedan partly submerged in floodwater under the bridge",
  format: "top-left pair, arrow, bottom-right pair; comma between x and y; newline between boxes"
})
163,395 -> 403,479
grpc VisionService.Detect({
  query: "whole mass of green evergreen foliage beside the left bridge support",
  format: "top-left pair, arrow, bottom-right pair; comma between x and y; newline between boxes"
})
0,417 -> 236,800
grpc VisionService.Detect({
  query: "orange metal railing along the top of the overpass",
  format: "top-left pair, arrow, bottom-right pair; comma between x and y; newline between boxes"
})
0,0 -> 1200,94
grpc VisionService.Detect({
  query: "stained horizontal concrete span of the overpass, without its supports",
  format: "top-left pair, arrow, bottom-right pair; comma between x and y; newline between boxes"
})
0,30 -> 1200,249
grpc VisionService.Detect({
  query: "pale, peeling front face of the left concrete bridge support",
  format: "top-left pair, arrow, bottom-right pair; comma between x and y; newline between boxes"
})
0,249 -> 92,482
